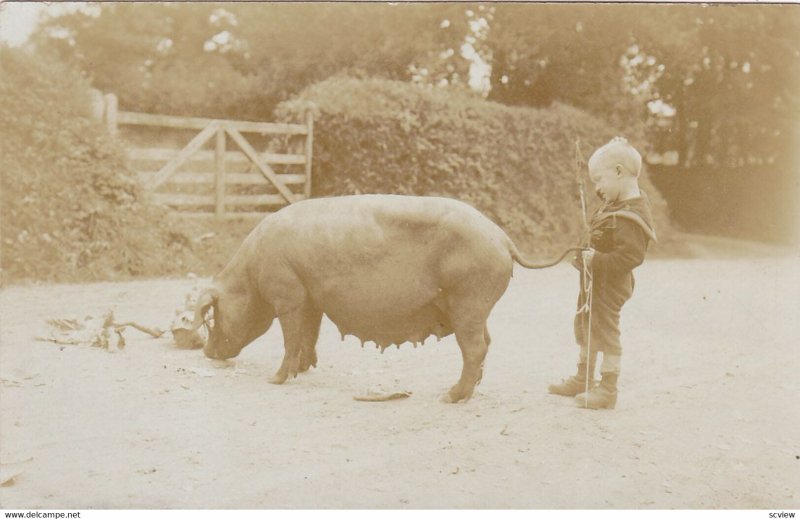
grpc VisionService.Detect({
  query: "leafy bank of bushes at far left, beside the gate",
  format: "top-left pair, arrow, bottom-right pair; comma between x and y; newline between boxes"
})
0,48 -> 244,281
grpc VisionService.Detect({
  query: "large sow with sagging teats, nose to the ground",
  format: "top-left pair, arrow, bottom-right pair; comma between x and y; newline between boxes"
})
194,195 -> 560,402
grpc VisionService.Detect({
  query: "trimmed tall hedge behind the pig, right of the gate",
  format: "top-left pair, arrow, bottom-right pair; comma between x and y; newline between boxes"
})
276,77 -> 669,257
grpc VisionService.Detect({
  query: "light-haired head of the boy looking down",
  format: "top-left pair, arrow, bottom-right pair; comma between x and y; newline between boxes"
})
589,137 -> 642,202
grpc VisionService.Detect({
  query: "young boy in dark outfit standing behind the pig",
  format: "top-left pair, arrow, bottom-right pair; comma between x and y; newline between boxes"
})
548,137 -> 656,409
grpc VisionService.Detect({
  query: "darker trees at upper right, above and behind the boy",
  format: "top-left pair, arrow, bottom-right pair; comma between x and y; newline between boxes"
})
488,4 -> 800,166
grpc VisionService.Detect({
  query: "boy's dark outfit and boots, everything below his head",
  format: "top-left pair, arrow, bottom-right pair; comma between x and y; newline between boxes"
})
550,192 -> 656,407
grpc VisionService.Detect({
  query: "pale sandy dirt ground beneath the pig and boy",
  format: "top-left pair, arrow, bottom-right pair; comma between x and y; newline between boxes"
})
0,255 -> 800,509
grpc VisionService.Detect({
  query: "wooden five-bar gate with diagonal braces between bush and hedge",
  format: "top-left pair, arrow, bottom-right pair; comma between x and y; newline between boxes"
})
97,95 -> 314,218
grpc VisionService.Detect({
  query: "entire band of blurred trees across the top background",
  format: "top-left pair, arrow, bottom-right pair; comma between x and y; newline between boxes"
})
31,2 -> 800,166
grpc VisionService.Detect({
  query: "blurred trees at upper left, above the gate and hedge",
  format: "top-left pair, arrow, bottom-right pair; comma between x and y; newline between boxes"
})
36,3 -> 463,119
